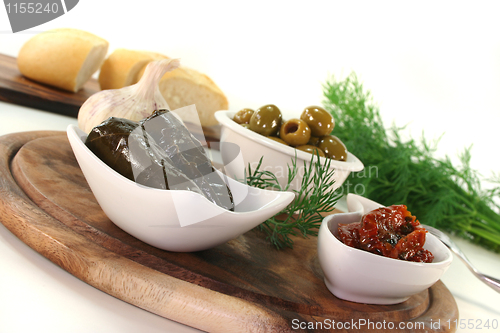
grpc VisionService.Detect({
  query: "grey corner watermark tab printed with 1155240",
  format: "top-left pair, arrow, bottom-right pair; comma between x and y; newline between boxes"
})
3,0 -> 78,33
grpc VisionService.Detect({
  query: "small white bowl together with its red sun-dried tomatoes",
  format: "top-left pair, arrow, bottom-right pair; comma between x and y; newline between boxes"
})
318,194 -> 453,304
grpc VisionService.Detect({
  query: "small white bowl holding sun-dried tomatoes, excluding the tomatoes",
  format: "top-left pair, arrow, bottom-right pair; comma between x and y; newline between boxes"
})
318,194 -> 453,304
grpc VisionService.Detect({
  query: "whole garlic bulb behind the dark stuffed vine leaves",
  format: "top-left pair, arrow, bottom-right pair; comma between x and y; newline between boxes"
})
78,59 -> 180,133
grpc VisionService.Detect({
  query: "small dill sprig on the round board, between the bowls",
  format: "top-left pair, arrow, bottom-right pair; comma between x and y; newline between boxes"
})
246,155 -> 340,249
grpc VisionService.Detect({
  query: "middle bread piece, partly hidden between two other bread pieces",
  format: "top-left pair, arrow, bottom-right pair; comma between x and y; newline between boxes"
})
99,49 -> 168,90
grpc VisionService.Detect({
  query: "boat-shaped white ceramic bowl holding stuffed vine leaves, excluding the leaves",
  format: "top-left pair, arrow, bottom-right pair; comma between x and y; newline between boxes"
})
67,125 -> 294,252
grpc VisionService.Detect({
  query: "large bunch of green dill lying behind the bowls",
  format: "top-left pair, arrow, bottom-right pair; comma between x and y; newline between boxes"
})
323,72 -> 500,252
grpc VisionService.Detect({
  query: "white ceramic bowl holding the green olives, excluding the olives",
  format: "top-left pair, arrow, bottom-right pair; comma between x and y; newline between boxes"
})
215,111 -> 363,190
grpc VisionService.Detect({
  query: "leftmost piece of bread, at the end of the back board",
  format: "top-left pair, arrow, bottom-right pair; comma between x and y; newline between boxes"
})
17,28 -> 109,92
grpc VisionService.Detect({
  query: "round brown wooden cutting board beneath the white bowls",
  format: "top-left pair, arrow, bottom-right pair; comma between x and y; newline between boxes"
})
0,132 -> 458,332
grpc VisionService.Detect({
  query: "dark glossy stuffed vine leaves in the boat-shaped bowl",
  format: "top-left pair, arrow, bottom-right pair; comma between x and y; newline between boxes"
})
85,110 -> 234,210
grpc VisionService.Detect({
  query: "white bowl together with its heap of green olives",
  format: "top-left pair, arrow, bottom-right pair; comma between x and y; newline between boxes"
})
215,104 -> 364,190
